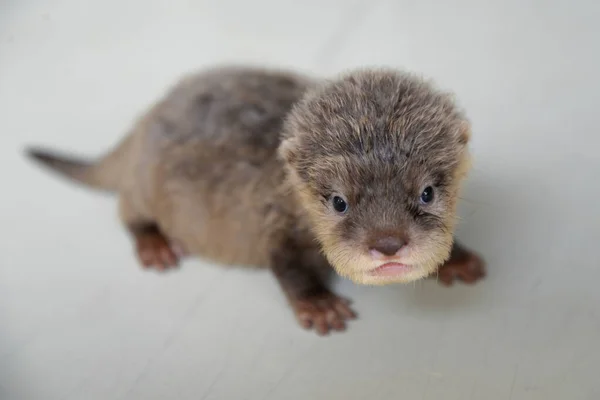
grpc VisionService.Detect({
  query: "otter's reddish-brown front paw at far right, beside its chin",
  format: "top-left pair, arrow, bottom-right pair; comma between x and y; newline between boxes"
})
433,242 -> 485,286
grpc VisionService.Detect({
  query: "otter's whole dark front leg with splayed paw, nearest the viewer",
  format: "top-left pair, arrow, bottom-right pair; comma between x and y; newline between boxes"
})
271,239 -> 356,335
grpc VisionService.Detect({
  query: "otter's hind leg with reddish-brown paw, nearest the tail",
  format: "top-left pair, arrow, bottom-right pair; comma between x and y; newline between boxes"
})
119,196 -> 181,271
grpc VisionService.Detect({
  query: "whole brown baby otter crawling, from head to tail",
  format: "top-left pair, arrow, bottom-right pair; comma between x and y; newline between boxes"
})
29,66 -> 484,334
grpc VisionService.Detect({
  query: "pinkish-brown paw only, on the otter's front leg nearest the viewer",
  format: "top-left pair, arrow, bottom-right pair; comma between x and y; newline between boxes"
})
292,292 -> 356,336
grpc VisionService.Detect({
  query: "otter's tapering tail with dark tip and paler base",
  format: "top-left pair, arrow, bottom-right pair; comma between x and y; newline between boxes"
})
26,137 -> 131,192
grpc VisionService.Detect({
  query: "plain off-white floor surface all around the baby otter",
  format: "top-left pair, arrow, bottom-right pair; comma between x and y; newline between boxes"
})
0,0 -> 600,400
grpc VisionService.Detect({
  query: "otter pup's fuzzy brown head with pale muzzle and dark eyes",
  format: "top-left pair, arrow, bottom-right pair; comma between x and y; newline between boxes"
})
280,70 -> 470,284
